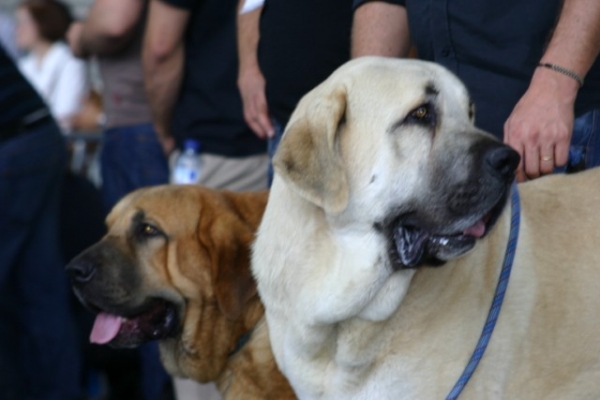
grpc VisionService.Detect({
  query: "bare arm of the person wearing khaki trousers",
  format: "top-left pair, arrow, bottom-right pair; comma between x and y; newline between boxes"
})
142,0 -> 189,154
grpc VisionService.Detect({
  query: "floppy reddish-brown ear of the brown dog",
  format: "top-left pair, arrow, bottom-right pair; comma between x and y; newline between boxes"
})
199,205 -> 257,319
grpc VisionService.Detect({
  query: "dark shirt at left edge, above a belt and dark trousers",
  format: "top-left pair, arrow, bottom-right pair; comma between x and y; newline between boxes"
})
0,45 -> 45,126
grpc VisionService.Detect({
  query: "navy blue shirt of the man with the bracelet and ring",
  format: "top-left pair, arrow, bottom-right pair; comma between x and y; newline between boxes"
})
354,0 -> 600,138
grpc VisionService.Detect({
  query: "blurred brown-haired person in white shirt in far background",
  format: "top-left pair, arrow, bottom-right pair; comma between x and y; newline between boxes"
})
16,0 -> 89,132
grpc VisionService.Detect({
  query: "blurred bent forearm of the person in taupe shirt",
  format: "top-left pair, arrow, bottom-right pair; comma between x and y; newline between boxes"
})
67,0 -> 144,58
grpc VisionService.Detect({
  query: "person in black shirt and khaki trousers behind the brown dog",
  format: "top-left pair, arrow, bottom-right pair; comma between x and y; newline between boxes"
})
142,0 -> 268,191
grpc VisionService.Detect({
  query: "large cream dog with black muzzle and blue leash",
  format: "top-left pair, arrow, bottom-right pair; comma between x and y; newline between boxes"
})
252,58 -> 600,400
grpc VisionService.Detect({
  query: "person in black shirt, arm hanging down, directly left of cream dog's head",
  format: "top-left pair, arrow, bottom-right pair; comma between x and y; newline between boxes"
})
237,0 -> 352,182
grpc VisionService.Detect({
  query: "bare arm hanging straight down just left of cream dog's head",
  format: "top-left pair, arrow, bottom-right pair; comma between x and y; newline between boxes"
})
237,0 -> 274,139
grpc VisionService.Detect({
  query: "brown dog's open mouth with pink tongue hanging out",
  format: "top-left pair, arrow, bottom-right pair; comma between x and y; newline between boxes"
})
86,299 -> 180,348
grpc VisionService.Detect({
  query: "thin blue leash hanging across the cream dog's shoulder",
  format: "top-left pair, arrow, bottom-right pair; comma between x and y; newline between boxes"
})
446,185 -> 521,400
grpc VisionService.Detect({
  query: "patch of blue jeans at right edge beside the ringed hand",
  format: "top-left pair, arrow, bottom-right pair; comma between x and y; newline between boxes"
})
557,109 -> 600,172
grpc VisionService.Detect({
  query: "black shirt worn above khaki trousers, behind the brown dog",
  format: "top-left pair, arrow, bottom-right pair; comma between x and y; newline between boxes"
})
162,0 -> 267,157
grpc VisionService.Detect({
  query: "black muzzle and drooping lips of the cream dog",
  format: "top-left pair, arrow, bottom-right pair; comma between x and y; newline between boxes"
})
382,136 -> 519,269
